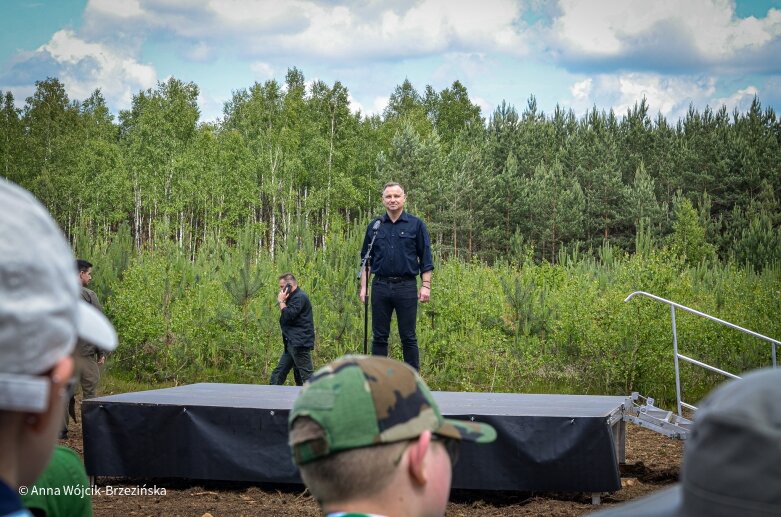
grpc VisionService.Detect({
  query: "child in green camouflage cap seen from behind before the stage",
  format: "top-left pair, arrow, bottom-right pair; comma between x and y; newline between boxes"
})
288,355 -> 496,517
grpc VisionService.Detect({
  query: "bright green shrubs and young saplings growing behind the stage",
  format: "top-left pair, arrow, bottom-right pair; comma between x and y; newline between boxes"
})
93,225 -> 781,405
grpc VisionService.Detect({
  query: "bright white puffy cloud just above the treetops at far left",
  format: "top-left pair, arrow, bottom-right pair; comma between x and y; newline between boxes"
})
38,30 -> 157,108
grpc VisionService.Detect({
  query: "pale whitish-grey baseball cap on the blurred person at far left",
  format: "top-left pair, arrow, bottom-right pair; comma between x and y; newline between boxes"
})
0,178 -> 117,412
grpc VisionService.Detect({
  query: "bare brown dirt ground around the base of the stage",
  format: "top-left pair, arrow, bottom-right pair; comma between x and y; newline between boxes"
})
61,404 -> 683,517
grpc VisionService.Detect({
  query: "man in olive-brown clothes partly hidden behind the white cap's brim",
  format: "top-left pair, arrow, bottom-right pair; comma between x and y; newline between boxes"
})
60,259 -> 106,439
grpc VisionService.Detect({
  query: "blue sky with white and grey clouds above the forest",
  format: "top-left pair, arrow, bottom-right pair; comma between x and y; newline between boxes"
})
0,0 -> 781,120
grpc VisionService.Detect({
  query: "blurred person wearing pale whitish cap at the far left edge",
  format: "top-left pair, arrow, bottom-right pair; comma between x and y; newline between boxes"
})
0,179 -> 117,516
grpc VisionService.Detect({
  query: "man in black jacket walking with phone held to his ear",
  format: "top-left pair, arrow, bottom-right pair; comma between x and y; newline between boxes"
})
269,273 -> 315,386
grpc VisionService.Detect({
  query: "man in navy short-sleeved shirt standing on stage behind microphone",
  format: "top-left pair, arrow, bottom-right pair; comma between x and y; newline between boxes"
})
360,183 -> 434,370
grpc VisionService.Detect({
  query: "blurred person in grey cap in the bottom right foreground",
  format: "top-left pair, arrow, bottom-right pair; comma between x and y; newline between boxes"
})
592,369 -> 781,517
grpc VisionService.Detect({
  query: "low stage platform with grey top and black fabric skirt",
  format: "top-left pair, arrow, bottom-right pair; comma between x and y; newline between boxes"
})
82,384 -> 625,493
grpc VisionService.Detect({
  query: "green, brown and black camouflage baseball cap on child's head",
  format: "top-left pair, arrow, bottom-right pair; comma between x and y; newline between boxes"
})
288,355 -> 496,465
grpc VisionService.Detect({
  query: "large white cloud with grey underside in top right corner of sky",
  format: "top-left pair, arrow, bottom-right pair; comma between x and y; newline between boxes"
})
548,0 -> 781,68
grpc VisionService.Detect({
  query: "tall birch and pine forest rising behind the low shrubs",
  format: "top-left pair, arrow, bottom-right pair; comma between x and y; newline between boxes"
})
0,73 -> 781,268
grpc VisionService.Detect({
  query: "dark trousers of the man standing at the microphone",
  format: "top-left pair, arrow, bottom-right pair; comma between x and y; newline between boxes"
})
371,277 -> 420,370
